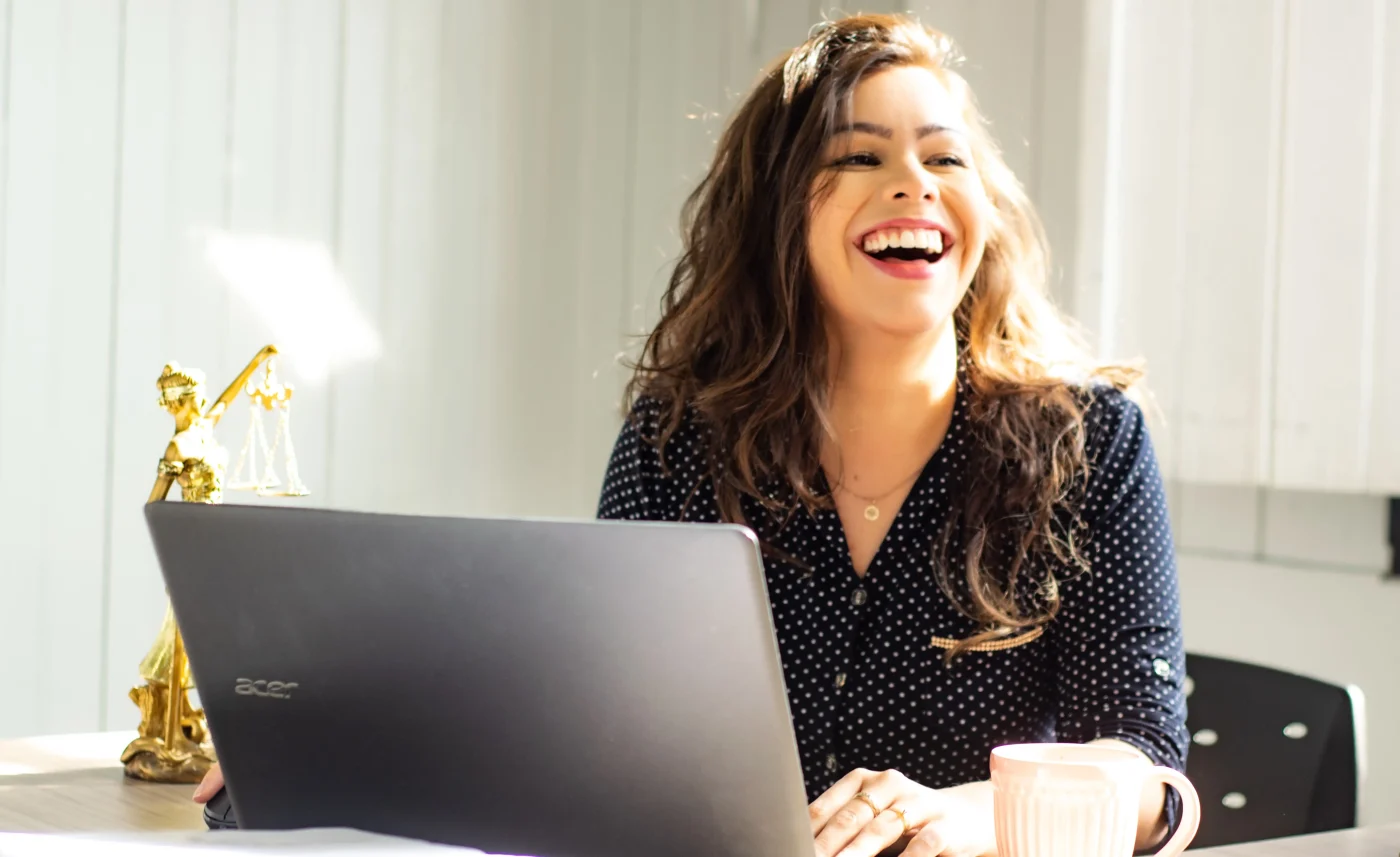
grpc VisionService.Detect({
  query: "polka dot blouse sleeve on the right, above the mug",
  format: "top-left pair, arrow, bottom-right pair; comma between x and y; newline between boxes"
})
1047,389 -> 1189,778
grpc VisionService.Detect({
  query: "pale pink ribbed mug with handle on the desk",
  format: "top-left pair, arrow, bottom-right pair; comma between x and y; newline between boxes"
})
991,744 -> 1201,857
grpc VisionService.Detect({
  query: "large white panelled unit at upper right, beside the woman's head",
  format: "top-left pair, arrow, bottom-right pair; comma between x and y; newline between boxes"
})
1081,0 -> 1400,493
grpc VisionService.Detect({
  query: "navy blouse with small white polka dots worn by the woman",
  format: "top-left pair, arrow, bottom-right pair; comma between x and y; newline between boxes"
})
598,372 -> 1187,806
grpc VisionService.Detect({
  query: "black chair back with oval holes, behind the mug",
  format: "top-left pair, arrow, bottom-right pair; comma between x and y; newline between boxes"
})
1186,654 -> 1365,847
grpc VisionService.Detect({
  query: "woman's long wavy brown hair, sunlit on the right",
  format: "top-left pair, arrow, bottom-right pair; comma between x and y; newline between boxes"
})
627,15 -> 1138,657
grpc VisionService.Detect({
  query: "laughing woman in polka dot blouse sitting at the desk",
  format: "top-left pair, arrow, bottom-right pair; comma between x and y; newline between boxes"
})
598,15 -> 1187,857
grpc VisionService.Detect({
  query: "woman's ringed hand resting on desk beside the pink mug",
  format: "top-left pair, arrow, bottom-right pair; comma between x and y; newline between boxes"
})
808,769 -> 997,857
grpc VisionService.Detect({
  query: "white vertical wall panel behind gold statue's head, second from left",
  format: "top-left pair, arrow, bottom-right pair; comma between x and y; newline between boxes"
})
101,0 -> 237,728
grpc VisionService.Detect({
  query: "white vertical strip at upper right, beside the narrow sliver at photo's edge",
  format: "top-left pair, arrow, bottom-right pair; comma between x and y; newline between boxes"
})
1273,0 -> 1383,490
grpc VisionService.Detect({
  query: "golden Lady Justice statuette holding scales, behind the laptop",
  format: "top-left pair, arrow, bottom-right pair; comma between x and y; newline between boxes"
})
122,346 -> 311,783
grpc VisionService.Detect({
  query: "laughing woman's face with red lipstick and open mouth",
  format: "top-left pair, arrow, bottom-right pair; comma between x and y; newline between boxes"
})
808,66 -> 993,336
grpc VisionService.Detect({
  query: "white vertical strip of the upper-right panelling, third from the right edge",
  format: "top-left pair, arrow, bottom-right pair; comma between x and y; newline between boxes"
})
1176,0 -> 1285,485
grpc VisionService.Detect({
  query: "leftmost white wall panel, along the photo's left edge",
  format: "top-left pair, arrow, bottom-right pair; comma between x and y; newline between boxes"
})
0,0 -> 122,731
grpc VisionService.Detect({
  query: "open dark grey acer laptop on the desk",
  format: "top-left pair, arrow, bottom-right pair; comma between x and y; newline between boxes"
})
146,503 -> 813,857
